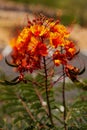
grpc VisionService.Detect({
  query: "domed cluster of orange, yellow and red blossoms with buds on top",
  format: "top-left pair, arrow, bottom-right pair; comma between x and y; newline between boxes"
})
11,16 -> 76,77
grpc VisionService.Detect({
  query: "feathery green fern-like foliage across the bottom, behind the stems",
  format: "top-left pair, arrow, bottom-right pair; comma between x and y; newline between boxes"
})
0,72 -> 87,130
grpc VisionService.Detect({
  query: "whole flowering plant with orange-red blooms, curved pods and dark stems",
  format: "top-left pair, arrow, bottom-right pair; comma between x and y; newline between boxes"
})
0,15 -> 85,130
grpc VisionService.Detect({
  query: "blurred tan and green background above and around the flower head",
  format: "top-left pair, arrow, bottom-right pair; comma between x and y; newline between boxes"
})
0,0 -> 87,77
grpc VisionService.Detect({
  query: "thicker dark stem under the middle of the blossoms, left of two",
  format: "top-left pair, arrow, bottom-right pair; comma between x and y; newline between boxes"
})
43,57 -> 54,126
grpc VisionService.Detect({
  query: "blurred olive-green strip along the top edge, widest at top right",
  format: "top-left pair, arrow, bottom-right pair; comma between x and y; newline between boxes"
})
8,0 -> 87,26
